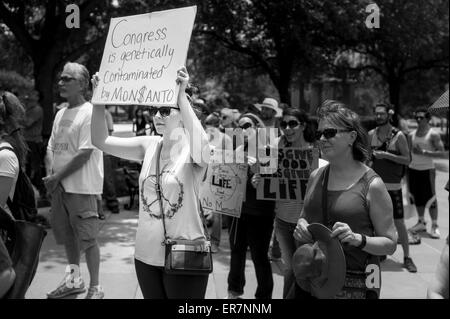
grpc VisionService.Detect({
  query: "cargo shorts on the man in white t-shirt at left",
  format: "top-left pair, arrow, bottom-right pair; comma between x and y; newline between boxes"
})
50,184 -> 100,251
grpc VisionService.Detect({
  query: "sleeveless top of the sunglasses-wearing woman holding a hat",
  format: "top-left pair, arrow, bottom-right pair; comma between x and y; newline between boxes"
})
303,166 -> 379,271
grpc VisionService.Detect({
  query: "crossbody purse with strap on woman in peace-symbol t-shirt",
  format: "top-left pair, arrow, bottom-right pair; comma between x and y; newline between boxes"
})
156,142 -> 213,275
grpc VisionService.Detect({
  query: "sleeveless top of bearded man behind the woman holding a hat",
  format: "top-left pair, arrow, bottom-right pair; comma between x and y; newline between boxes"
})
370,128 -> 406,190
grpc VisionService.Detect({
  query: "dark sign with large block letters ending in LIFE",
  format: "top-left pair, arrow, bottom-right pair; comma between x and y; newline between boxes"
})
256,148 -> 319,202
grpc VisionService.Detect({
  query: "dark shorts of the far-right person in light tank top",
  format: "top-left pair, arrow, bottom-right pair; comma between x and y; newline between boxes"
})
408,168 -> 436,207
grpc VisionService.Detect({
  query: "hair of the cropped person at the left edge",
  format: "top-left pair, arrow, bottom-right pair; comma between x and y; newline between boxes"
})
0,92 -> 28,168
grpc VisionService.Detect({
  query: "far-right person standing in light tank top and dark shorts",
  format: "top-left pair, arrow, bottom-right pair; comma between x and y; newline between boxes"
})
408,108 -> 447,239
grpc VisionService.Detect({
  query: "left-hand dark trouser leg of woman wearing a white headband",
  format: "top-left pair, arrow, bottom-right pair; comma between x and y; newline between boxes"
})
228,215 -> 248,296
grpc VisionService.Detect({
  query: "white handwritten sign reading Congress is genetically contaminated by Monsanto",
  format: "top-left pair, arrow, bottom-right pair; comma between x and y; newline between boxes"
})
92,6 -> 197,106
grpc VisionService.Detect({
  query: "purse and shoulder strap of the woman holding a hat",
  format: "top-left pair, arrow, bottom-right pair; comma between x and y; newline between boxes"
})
322,166 -> 373,299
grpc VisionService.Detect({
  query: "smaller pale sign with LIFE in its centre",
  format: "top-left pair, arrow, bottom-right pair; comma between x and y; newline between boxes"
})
200,149 -> 248,218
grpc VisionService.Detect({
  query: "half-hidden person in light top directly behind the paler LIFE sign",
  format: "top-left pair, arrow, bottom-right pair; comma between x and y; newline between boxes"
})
204,112 -> 233,253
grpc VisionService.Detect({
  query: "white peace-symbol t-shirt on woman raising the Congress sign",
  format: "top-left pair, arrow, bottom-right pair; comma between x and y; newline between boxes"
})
135,136 -> 205,266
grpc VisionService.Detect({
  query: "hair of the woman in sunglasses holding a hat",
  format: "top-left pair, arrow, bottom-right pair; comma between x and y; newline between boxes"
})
317,100 -> 369,163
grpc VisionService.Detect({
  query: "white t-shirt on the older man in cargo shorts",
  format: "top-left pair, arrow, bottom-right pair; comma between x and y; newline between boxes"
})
47,102 -> 103,194
